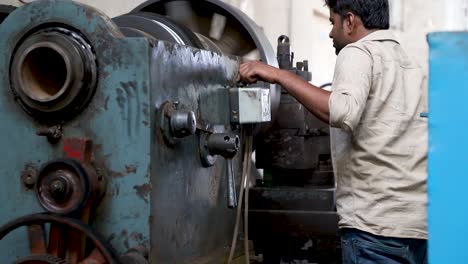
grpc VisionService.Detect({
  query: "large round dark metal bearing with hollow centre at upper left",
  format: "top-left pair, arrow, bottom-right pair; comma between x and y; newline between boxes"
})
10,27 -> 97,120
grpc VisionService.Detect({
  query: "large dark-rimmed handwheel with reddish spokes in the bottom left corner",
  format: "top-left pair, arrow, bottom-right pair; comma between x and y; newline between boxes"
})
0,213 -> 118,264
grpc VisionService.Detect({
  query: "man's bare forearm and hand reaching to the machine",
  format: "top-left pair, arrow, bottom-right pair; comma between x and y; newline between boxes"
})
239,61 -> 331,124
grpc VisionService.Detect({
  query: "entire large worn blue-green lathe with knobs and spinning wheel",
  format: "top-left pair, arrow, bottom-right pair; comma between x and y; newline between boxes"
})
0,0 -> 336,263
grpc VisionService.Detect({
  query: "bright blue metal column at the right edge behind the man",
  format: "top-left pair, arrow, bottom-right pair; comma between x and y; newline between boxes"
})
428,32 -> 468,264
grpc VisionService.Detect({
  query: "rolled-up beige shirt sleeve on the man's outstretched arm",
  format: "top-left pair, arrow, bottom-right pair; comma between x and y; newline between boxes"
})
328,46 -> 372,132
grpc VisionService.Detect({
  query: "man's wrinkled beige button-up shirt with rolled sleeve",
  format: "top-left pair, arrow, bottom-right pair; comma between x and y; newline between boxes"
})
329,30 -> 428,239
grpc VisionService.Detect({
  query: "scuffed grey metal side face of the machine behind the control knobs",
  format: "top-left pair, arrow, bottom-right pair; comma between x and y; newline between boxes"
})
150,42 -> 241,263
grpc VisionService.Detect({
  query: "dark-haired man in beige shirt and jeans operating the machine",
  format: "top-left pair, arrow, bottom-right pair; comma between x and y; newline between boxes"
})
239,0 -> 427,263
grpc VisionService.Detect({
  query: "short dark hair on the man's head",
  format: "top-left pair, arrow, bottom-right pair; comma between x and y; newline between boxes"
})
325,0 -> 390,29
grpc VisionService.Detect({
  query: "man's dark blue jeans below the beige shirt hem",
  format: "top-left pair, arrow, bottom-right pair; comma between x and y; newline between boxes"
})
341,229 -> 427,264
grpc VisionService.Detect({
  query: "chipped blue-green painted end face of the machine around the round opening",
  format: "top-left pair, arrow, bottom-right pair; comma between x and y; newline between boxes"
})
0,1 -> 153,263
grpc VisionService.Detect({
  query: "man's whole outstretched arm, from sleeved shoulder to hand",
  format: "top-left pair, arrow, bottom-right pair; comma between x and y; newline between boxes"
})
239,46 -> 373,131
